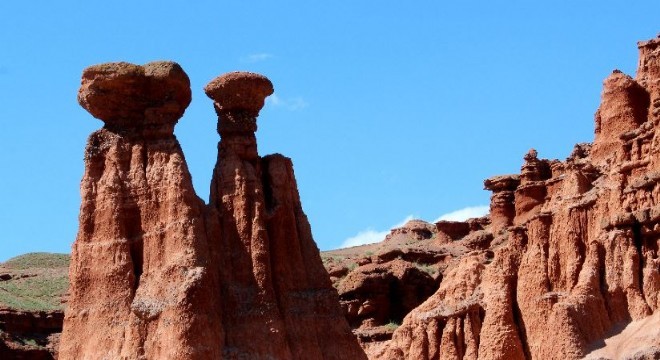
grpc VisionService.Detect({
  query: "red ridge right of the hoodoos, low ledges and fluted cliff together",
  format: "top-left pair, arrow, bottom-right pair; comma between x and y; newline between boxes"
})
323,38 -> 660,360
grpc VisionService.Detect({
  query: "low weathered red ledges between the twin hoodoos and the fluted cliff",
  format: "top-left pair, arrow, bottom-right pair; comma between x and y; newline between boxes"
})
322,218 -> 493,355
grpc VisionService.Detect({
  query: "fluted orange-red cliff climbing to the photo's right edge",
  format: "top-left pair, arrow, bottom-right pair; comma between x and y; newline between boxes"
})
371,38 -> 660,360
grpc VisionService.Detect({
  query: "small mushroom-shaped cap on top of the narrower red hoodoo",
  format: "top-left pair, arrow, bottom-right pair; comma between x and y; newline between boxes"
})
204,71 -> 273,116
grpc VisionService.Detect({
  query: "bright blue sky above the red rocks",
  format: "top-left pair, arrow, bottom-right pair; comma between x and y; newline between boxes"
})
0,0 -> 660,261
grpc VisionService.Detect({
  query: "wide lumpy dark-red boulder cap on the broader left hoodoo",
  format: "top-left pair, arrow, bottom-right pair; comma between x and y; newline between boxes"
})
78,61 -> 191,129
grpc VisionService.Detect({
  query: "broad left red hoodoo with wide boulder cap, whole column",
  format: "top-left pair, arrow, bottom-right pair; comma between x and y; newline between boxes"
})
60,62 -> 223,360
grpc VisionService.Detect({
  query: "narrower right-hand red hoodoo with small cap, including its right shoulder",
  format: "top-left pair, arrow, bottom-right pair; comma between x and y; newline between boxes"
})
205,72 -> 366,360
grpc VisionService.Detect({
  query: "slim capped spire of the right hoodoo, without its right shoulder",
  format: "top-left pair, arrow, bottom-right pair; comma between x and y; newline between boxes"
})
204,72 -> 291,359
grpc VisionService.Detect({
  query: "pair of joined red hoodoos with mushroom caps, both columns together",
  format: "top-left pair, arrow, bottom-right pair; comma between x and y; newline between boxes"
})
60,62 -> 365,359
